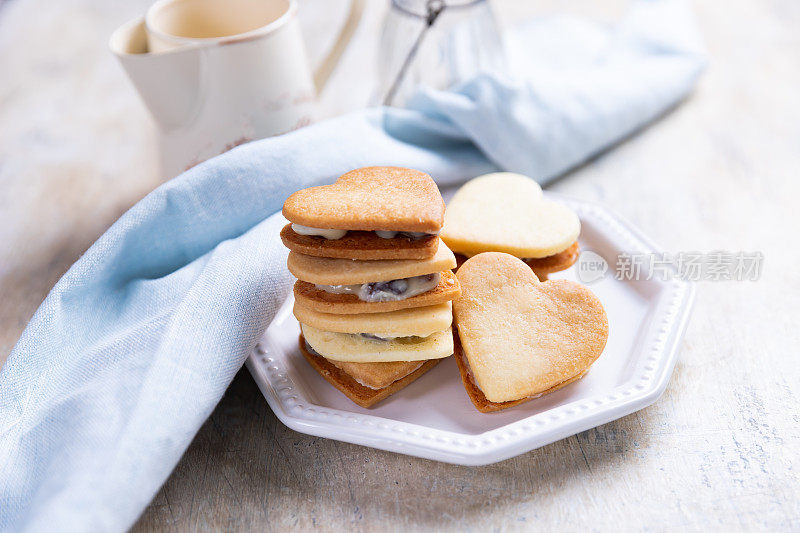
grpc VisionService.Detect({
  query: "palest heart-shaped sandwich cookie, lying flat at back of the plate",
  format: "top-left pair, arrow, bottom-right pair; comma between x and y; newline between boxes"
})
440,172 -> 581,258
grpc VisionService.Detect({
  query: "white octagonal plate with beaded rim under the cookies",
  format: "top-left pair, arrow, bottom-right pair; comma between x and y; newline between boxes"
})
247,194 -> 694,465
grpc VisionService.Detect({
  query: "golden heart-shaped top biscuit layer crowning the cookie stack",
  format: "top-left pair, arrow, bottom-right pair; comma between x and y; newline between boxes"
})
283,167 -> 444,233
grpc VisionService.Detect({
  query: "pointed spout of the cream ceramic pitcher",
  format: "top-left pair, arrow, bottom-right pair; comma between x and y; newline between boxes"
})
109,17 -> 203,131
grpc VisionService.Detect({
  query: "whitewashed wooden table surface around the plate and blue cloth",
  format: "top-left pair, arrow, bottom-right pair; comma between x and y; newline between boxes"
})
0,0 -> 800,531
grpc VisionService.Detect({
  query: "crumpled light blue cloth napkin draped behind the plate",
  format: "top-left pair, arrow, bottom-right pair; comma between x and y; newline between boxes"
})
0,0 -> 704,531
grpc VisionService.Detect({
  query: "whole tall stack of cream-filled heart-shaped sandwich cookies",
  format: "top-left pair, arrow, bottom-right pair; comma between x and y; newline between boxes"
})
281,167 -> 461,407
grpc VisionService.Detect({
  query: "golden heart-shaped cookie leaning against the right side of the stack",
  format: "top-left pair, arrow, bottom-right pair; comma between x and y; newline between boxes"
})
453,252 -> 608,410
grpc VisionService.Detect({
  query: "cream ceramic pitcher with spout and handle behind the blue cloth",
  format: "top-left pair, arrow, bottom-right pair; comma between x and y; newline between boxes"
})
109,0 -> 364,178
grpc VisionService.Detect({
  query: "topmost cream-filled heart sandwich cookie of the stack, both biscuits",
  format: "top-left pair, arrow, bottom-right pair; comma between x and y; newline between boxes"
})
281,167 -> 444,260
